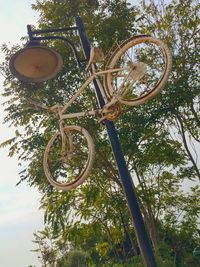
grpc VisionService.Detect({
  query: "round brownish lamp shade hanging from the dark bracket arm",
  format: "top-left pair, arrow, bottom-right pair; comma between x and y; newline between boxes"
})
10,45 -> 63,83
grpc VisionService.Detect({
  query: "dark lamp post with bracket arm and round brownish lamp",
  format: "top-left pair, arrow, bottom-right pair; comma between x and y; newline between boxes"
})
10,16 -> 157,267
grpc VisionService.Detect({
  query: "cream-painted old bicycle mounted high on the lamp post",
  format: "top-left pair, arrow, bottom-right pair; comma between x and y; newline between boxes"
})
38,35 -> 172,191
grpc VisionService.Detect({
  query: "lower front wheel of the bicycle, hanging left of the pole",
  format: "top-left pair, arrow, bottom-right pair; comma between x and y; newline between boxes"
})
43,126 -> 94,191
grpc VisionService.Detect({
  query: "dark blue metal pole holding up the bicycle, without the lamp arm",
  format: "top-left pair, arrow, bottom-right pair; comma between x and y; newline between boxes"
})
76,16 -> 157,267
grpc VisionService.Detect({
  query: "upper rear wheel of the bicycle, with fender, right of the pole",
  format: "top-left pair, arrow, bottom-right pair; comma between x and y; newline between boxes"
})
105,35 -> 172,106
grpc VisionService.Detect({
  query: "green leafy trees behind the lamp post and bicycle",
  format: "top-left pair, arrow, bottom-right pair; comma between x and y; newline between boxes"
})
0,0 -> 200,267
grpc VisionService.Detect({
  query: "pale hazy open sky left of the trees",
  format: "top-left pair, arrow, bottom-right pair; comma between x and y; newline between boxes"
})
0,0 -> 43,267
